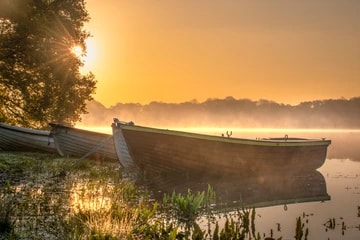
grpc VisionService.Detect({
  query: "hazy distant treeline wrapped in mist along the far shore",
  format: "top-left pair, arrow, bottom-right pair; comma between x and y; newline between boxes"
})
81,97 -> 360,129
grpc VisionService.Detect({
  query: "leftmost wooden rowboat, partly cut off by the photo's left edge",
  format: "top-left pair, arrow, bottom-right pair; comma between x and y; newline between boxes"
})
0,123 -> 56,153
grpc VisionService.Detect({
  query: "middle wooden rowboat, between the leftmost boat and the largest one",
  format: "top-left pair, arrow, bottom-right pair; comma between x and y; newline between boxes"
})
49,123 -> 118,160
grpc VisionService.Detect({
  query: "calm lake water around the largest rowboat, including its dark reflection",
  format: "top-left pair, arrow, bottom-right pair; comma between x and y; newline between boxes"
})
79,128 -> 360,240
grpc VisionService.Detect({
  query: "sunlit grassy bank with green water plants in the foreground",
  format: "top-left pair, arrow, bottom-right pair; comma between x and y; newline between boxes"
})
0,152 -> 306,239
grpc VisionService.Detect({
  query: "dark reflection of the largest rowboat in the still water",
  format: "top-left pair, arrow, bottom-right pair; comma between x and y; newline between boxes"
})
138,170 -> 330,210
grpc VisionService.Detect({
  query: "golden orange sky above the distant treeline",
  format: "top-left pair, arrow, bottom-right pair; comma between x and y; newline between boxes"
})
85,0 -> 360,106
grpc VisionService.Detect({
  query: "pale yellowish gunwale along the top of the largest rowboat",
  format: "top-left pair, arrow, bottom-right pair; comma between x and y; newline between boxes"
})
120,124 -> 331,147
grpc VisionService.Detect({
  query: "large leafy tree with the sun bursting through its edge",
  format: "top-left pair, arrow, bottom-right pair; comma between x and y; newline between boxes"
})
0,0 -> 96,128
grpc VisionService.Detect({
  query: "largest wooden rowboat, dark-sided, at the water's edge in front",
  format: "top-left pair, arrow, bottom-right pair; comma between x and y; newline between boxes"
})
112,119 -> 331,175
